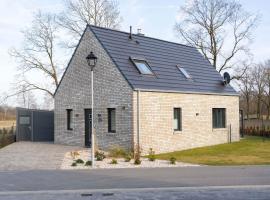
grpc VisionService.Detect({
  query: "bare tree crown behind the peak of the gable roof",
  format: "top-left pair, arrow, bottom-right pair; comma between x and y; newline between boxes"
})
58,0 -> 122,47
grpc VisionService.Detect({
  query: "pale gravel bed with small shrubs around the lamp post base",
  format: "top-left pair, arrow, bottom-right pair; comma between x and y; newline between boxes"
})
61,149 -> 200,170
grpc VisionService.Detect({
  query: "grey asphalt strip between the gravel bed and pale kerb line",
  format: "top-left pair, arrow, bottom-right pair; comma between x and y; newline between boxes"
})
0,166 -> 270,191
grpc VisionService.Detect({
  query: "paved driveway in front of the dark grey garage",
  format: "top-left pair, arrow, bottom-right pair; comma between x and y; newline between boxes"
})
0,142 -> 83,171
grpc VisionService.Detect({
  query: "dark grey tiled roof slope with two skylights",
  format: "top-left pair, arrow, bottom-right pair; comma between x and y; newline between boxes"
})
89,26 -> 238,95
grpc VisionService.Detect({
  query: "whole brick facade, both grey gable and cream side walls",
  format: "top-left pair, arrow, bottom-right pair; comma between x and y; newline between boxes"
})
55,26 -> 239,153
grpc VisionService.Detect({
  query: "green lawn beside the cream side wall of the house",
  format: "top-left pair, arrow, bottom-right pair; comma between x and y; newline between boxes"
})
156,136 -> 270,165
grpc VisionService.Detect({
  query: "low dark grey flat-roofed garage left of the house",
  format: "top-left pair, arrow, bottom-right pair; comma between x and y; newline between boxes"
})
16,108 -> 54,142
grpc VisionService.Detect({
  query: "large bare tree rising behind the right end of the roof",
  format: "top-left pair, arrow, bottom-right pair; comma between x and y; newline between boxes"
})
175,0 -> 258,74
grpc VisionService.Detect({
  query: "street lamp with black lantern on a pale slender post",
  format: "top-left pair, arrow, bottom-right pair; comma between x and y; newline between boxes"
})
86,51 -> 97,167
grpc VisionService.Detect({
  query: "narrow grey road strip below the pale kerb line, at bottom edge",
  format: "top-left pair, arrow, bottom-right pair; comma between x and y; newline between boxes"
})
0,186 -> 270,200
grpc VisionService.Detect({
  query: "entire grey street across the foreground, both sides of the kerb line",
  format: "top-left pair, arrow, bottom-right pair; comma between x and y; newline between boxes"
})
0,166 -> 270,200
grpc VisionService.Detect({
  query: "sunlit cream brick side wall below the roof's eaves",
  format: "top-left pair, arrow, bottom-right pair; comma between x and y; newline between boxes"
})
133,91 -> 239,153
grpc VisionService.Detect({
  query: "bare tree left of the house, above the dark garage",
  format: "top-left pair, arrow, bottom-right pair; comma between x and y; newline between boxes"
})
10,12 -> 59,97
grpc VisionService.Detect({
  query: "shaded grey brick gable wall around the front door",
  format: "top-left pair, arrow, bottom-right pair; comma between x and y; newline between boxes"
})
55,27 -> 133,149
